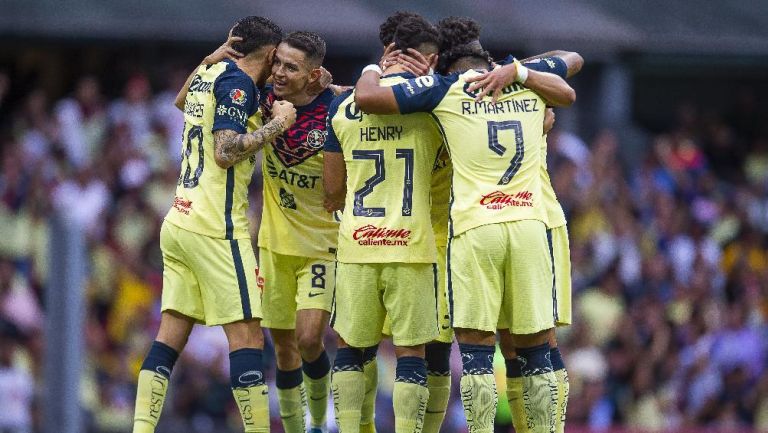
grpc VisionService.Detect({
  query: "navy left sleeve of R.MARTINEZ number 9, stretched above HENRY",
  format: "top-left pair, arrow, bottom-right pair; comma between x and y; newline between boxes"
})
392,74 -> 459,114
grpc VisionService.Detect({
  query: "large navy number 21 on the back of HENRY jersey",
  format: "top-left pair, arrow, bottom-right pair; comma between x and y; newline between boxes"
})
352,149 -> 413,217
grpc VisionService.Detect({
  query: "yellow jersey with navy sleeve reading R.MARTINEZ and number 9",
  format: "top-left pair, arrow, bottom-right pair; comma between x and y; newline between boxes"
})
393,57 -> 568,236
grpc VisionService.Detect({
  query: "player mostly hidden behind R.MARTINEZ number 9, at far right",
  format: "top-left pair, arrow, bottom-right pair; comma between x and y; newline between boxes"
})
469,51 -> 584,433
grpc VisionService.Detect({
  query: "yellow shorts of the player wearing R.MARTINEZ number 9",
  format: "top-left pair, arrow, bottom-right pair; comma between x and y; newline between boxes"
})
448,220 -> 556,334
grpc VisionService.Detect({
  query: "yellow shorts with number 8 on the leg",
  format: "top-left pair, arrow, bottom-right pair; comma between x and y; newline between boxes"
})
259,248 -> 336,329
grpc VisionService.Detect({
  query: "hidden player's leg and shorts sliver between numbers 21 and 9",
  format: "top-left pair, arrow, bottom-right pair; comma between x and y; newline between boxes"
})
422,247 -> 453,433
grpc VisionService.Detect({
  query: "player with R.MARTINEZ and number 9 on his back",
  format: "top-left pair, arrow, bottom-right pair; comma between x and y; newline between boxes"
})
355,17 -> 575,433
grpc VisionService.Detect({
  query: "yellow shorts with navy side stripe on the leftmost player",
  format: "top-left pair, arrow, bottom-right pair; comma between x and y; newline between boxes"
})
160,221 -> 261,326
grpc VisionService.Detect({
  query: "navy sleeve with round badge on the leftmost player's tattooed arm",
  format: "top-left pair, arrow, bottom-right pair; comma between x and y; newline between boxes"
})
212,71 -> 259,134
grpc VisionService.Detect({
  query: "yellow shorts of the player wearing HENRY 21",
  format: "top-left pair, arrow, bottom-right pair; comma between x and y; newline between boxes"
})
331,263 -> 438,347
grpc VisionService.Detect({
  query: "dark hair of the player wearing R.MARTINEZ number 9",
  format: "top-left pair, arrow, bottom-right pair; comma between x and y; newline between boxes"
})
437,17 -> 493,74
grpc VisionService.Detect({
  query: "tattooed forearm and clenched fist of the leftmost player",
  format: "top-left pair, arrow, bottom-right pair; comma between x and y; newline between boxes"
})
213,101 -> 296,170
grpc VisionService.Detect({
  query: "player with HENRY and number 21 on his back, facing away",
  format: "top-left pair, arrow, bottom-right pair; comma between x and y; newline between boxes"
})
324,17 -> 441,433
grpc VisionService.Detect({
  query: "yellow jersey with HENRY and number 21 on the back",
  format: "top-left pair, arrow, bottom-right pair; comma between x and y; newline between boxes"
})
325,74 -> 442,263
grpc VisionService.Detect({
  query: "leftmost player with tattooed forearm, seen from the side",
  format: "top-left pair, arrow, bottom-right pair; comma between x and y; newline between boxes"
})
133,16 -> 295,433
